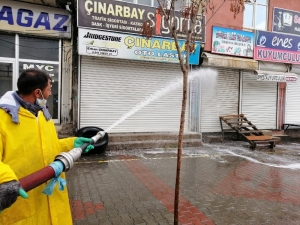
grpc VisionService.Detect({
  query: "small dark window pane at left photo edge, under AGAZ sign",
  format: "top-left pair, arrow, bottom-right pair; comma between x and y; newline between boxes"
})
0,34 -> 15,58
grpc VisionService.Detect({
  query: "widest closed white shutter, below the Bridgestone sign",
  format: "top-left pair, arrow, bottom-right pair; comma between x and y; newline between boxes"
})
79,56 -> 189,133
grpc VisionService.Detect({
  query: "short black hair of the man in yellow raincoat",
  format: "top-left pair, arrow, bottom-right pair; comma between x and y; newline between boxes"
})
17,69 -> 51,95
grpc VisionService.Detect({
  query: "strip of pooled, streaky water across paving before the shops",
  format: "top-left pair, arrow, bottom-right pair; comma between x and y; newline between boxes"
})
88,141 -> 300,169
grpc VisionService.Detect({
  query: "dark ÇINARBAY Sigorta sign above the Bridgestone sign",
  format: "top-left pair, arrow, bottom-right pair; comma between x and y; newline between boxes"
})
77,0 -> 205,42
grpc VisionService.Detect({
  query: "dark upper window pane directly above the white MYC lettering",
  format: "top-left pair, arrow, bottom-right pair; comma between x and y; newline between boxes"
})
19,37 -> 59,61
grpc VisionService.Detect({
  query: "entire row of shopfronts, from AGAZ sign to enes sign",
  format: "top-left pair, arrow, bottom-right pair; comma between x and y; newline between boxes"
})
0,0 -> 300,137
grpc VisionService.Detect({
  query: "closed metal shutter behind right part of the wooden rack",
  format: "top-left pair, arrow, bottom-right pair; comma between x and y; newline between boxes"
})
241,71 -> 277,129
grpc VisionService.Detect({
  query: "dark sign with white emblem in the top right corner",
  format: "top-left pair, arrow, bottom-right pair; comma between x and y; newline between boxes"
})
273,7 -> 300,35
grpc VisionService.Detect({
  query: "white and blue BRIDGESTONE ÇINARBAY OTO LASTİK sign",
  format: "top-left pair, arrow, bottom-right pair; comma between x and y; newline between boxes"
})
78,28 -> 200,65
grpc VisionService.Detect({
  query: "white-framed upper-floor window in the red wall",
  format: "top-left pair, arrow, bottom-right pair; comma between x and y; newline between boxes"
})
243,0 -> 268,30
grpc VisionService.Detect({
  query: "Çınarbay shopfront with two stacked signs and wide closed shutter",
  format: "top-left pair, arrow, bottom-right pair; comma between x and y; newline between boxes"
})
77,0 -> 205,133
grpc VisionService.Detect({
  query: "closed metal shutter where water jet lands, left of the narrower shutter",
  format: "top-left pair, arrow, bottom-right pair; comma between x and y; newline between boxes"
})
200,68 -> 239,132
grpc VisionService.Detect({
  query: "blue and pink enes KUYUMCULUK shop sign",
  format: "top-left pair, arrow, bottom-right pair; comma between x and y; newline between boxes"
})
254,31 -> 300,64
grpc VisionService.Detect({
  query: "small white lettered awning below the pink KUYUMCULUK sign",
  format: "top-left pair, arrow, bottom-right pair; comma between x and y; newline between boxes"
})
254,70 -> 298,82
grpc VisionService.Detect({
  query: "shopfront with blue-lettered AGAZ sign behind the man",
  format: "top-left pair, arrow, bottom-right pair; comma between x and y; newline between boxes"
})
0,0 -> 72,124
